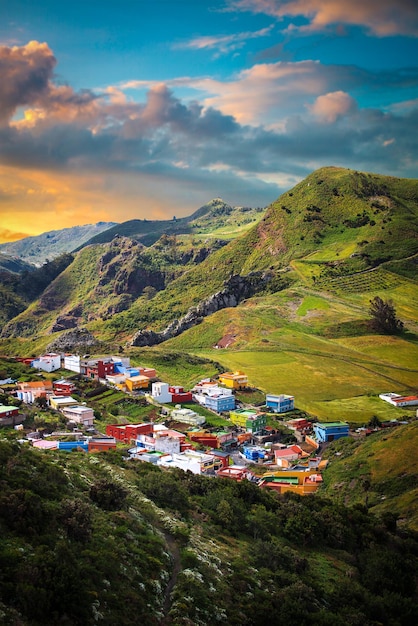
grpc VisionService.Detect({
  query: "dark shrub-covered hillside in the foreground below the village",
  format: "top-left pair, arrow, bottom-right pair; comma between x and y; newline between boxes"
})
0,439 -> 418,626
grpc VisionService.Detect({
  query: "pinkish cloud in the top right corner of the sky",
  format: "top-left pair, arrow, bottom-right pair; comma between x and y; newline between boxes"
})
228,0 -> 418,37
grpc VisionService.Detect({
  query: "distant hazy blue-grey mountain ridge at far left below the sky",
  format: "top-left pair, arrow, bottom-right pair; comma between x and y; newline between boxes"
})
0,222 -> 115,265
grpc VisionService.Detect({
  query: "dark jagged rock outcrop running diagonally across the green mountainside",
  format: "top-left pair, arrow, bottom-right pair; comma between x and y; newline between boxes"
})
131,272 -> 273,347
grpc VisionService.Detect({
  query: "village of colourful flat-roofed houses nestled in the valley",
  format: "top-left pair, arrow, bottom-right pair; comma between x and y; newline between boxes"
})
0,353 -> 418,495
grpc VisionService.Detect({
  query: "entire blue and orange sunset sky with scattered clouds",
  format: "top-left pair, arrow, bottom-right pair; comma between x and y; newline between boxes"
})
0,0 -> 418,242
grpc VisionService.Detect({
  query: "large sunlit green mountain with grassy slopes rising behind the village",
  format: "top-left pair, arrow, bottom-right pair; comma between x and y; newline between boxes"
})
1,167 -> 418,425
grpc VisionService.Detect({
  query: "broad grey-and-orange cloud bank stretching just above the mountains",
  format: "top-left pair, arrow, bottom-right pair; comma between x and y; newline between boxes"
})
0,42 -> 418,237
